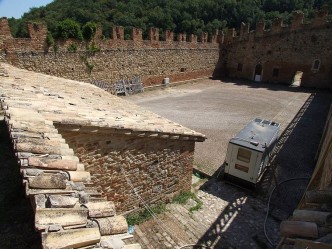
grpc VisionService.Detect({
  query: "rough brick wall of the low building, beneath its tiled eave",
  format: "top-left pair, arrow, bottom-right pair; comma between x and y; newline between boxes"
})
60,130 -> 195,212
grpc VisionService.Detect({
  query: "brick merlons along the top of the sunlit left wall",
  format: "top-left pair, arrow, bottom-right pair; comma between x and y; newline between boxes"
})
0,18 -> 223,53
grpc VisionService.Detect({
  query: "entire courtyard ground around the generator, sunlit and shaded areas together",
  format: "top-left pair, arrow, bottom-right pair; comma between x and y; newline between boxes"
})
126,79 -> 332,249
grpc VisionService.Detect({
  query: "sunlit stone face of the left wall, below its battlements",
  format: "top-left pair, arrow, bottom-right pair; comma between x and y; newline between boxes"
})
16,48 -> 219,86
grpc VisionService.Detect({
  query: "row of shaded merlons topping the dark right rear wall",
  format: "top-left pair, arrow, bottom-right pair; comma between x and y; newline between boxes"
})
225,10 -> 330,44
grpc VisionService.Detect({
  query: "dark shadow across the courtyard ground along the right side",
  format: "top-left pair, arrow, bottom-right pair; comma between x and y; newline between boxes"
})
197,90 -> 332,249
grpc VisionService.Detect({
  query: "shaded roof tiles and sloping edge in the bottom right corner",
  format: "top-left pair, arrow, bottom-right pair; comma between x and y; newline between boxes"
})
278,107 -> 332,249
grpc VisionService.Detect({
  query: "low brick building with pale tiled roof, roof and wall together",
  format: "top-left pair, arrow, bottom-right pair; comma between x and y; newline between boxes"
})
0,64 -> 205,248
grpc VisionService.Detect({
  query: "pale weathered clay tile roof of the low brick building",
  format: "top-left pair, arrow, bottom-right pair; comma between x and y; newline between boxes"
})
0,63 -> 176,249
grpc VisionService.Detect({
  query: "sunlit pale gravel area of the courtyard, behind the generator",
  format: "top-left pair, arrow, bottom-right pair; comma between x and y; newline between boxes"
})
126,79 -> 311,175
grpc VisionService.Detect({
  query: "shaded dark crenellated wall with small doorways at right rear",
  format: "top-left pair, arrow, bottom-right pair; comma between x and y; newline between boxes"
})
221,12 -> 332,88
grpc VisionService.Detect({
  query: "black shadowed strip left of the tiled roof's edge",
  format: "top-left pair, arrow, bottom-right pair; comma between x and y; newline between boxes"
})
0,119 -> 41,249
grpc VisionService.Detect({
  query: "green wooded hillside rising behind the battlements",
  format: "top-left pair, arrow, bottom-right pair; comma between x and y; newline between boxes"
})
9,0 -> 332,39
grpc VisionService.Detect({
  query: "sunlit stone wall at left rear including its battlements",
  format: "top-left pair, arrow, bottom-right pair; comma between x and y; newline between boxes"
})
0,18 -> 222,86
